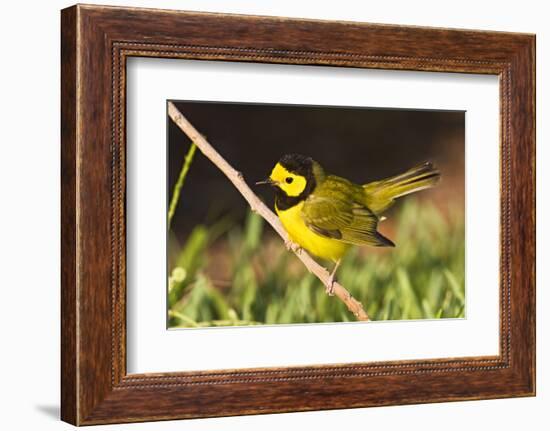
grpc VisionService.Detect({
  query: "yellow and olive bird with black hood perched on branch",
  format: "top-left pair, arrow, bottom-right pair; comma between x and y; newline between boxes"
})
256,154 -> 441,295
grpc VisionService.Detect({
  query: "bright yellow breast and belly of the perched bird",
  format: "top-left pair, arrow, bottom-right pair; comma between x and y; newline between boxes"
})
275,202 -> 350,262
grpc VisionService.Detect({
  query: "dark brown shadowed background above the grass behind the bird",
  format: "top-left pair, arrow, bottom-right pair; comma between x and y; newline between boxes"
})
167,101 -> 464,241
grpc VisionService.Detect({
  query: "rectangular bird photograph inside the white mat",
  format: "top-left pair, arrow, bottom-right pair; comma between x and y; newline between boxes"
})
166,100 -> 466,329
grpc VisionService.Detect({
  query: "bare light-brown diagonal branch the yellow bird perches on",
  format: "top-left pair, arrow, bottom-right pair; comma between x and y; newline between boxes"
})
168,102 -> 369,321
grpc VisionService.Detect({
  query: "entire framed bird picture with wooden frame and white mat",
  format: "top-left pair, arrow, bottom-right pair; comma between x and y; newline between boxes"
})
61,5 -> 535,425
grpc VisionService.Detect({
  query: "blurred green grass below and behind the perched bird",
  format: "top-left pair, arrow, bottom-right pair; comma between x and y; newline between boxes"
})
168,197 -> 465,328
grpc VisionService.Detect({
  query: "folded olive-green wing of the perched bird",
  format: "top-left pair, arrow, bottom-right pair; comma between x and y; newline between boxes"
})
302,190 -> 394,247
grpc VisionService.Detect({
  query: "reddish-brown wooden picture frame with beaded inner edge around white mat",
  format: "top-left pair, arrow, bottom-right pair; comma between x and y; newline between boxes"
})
61,5 -> 535,425
